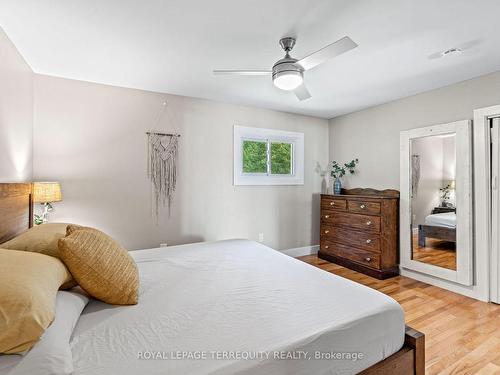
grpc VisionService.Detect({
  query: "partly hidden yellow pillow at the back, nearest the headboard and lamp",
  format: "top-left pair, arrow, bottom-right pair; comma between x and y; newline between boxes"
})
0,223 -> 68,258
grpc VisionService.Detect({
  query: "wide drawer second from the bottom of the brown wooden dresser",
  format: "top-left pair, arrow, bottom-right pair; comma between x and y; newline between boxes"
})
321,228 -> 380,253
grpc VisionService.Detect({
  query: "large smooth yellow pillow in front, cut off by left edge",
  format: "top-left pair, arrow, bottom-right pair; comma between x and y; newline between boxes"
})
0,249 -> 71,354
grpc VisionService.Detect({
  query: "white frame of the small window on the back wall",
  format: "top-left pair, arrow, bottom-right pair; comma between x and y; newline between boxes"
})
233,125 -> 304,185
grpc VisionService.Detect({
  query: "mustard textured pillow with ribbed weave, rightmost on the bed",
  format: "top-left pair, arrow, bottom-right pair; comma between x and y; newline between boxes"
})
59,226 -> 139,305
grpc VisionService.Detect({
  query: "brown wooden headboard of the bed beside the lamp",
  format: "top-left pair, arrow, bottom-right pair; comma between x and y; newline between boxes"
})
0,183 -> 33,244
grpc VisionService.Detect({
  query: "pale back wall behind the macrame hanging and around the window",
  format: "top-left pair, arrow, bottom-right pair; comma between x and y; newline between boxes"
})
34,75 -> 328,249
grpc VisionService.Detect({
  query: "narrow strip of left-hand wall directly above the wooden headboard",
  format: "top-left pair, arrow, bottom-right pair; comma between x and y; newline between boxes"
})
0,28 -> 33,182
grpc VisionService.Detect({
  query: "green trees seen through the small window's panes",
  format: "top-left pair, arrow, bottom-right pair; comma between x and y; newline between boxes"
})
243,140 -> 293,175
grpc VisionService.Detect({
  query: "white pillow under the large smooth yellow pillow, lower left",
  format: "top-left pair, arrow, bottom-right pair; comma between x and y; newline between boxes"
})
5,289 -> 89,375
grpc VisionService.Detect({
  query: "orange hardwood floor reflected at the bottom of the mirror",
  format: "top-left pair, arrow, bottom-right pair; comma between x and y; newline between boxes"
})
413,235 -> 457,270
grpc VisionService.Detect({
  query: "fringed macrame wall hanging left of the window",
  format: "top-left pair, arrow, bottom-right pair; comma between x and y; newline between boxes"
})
146,101 -> 180,220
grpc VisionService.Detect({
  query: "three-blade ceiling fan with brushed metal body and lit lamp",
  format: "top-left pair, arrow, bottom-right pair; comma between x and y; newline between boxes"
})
214,36 -> 358,100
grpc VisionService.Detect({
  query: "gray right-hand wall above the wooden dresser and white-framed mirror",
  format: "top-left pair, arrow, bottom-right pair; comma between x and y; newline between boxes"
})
329,72 -> 500,189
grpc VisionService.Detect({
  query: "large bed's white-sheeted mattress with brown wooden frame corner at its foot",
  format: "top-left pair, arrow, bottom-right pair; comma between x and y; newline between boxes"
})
0,184 -> 424,375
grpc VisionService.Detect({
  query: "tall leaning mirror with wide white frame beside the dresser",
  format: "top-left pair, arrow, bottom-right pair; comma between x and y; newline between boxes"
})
400,121 -> 472,285
